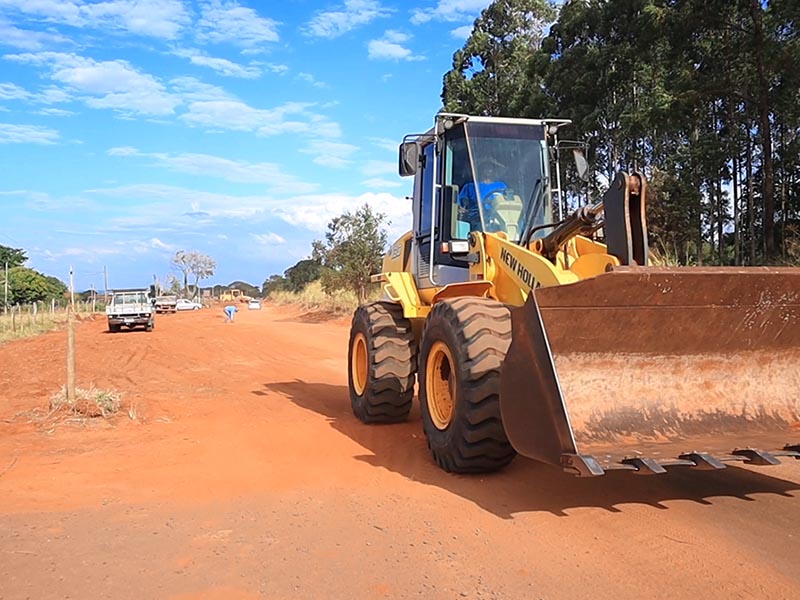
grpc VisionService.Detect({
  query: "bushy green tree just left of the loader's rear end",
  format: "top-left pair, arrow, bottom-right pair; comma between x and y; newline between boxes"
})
312,204 -> 387,303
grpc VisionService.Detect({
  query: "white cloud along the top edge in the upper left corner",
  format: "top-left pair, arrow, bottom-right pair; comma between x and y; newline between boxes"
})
0,0 -> 190,39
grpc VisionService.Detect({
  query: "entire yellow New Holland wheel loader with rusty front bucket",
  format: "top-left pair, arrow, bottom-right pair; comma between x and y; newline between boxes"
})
348,113 -> 800,476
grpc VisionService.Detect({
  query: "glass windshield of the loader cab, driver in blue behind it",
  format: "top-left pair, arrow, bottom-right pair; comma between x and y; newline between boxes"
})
445,122 -> 552,242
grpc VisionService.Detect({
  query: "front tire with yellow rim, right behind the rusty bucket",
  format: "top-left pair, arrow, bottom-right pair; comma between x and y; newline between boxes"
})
419,298 -> 516,473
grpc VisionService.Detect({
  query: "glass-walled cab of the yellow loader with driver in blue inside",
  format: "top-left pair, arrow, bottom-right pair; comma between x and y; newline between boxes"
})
400,114 -> 553,288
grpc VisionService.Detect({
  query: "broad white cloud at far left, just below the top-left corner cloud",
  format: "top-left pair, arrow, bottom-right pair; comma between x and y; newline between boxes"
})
4,52 -> 181,115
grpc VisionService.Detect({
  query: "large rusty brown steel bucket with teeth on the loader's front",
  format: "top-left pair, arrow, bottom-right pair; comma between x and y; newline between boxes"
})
500,267 -> 800,475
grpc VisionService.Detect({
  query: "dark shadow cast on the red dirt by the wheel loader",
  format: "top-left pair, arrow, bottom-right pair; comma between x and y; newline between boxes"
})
253,381 -> 800,518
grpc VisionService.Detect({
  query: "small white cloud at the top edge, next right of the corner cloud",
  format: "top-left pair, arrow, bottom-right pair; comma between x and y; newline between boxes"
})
198,0 -> 279,50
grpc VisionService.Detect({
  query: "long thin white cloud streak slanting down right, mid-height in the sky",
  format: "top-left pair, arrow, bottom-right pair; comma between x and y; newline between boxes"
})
108,146 -> 317,194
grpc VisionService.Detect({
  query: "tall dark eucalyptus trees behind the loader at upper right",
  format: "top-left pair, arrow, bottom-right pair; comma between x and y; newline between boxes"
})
442,0 -> 800,264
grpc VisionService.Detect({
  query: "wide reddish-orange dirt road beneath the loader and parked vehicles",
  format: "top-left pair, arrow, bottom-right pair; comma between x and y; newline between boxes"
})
0,307 -> 800,600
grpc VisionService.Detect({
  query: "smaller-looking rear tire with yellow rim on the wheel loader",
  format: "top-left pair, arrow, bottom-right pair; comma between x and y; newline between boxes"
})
347,302 -> 417,423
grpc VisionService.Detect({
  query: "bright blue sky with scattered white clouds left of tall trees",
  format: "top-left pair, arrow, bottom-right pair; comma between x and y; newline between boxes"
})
0,0 -> 496,290
